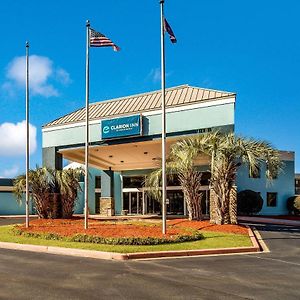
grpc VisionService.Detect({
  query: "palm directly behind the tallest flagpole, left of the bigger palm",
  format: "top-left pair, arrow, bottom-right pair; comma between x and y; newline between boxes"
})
145,140 -> 202,220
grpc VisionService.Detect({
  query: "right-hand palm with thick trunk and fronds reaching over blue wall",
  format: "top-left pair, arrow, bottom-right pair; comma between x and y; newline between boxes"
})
189,132 -> 282,224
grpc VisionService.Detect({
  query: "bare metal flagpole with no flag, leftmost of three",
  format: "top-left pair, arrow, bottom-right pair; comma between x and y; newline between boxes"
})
25,42 -> 30,228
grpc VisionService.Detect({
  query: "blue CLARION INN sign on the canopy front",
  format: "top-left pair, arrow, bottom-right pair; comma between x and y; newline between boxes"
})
101,115 -> 142,140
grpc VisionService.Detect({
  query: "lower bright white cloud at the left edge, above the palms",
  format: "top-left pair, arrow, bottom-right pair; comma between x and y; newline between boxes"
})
0,121 -> 37,156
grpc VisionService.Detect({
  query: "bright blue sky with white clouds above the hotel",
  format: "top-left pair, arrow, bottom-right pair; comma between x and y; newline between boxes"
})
0,0 -> 300,177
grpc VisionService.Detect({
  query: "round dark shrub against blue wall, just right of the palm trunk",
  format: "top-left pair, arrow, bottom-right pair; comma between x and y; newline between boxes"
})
237,190 -> 264,216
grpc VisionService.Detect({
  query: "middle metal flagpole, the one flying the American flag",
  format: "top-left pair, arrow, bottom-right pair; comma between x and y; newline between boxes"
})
84,20 -> 90,229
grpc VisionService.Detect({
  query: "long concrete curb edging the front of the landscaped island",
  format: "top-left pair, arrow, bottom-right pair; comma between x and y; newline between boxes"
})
0,227 -> 260,260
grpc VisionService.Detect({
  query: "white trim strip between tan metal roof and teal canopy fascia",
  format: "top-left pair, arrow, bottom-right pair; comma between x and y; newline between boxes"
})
42,97 -> 235,133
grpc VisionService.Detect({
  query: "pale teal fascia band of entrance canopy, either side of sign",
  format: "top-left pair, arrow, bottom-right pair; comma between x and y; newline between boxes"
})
43,103 -> 234,148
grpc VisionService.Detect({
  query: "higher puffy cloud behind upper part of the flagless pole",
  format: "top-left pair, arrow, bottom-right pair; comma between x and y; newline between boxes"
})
2,55 -> 71,97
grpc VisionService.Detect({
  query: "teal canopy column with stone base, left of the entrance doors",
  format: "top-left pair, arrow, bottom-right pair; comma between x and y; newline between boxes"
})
100,170 -> 115,216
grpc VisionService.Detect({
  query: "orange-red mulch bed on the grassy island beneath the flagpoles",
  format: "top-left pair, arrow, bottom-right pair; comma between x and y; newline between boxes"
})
19,218 -> 248,238
